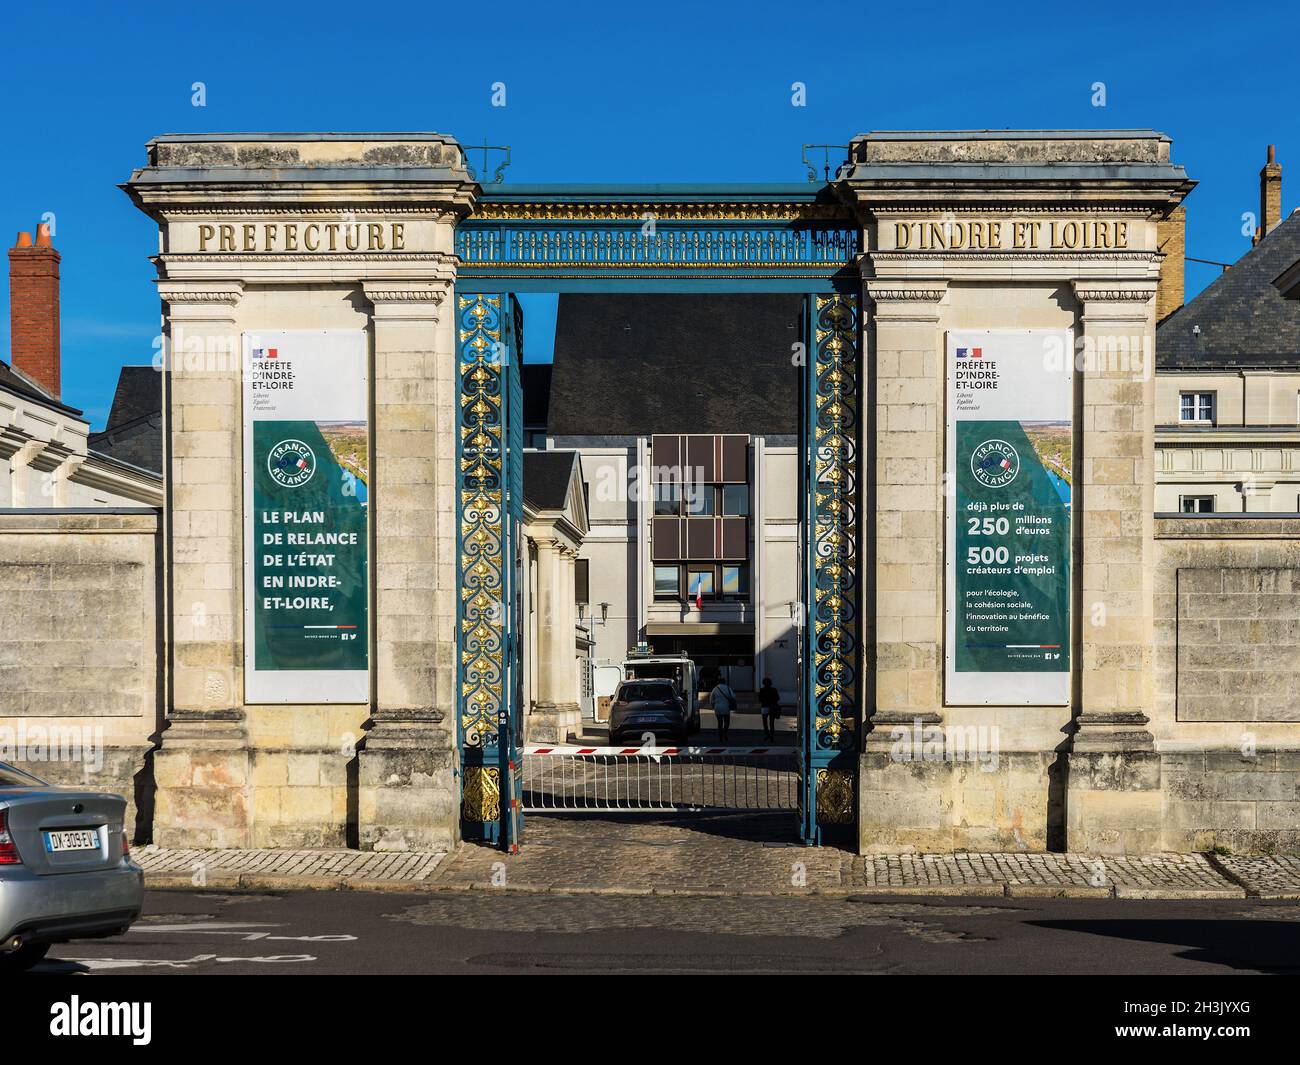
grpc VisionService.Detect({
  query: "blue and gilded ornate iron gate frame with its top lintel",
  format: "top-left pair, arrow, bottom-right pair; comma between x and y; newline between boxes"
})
456,185 -> 862,845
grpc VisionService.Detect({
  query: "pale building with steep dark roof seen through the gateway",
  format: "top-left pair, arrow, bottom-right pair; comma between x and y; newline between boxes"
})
535,294 -> 802,705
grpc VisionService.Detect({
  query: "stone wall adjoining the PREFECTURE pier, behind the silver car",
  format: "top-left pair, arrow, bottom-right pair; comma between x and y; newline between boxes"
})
0,508 -> 163,841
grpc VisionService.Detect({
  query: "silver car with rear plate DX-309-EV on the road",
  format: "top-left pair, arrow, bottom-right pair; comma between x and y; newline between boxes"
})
0,762 -> 144,973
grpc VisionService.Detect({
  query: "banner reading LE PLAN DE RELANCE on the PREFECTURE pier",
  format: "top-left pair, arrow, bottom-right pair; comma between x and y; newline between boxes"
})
243,330 -> 371,702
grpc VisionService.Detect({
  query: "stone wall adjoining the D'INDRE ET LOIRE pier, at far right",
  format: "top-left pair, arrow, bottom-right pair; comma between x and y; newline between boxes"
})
1152,515 -> 1300,852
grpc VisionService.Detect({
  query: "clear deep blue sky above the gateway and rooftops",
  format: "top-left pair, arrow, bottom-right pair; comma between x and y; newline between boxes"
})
0,0 -> 1300,427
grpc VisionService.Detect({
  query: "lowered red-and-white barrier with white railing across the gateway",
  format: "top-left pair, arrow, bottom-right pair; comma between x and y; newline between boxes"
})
524,744 -> 800,813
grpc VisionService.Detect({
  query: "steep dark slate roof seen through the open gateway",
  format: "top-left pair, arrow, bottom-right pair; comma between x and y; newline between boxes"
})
547,293 -> 803,437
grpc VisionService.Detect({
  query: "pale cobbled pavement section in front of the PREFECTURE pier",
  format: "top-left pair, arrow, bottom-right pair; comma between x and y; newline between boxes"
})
131,847 -> 446,887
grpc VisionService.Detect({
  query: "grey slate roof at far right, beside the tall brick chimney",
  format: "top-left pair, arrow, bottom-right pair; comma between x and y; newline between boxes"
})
1156,213 -> 1300,369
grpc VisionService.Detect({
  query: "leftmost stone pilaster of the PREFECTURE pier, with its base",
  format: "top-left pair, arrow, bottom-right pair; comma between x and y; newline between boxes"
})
153,281 -> 252,847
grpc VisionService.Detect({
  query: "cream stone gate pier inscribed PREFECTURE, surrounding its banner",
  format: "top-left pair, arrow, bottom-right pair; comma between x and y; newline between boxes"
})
124,133 -> 478,849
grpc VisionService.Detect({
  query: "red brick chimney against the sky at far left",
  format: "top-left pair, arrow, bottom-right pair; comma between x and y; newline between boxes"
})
9,222 -> 60,399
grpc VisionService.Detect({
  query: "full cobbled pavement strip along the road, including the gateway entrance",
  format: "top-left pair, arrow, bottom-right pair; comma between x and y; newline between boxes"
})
134,813 -> 1300,899
